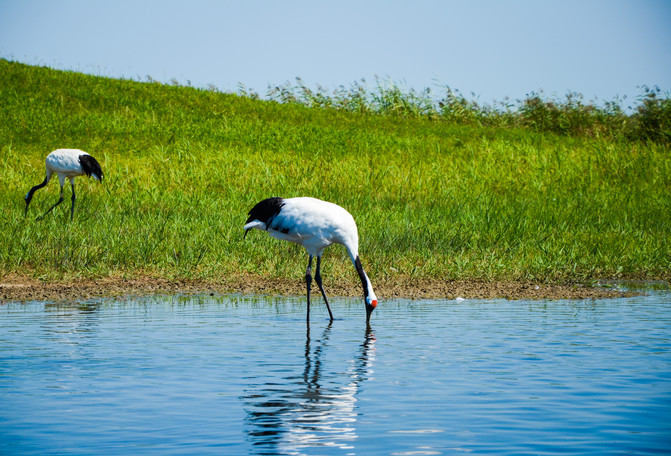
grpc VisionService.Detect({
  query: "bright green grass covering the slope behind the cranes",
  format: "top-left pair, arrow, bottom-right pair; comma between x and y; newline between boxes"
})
0,60 -> 671,282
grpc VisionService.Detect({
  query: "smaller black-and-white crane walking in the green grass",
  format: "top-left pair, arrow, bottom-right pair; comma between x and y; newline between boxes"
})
24,149 -> 103,220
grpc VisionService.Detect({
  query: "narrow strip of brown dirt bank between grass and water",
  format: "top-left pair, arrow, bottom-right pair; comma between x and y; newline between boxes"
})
0,275 -> 633,303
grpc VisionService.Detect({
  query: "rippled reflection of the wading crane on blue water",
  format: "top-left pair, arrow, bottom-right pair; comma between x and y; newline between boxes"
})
241,324 -> 375,454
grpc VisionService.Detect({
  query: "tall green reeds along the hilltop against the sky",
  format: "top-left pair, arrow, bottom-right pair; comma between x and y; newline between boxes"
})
266,78 -> 671,144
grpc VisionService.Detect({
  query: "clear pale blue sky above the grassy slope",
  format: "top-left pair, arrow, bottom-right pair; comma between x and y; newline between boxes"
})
0,0 -> 671,107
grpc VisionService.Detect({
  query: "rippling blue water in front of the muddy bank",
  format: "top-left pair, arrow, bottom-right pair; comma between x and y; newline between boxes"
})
0,292 -> 671,455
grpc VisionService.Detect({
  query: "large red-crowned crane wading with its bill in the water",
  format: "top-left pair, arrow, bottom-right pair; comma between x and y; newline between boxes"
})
243,197 -> 377,324
